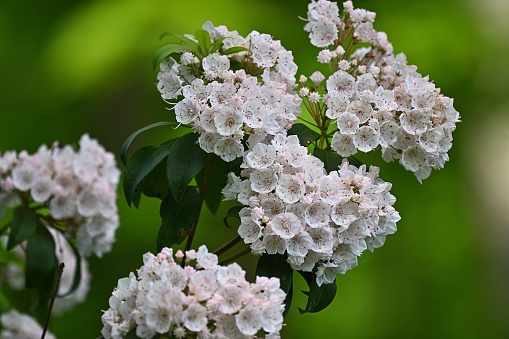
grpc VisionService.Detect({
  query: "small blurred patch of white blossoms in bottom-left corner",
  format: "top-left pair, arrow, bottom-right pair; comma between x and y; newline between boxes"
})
0,309 -> 55,339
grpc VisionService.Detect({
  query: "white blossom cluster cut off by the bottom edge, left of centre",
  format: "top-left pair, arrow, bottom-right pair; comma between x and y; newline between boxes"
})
101,245 -> 286,339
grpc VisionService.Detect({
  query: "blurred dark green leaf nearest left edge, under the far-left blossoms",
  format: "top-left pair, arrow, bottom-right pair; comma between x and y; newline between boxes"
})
7,206 -> 39,251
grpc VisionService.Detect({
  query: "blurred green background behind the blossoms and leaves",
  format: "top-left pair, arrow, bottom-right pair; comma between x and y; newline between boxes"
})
0,0 -> 509,338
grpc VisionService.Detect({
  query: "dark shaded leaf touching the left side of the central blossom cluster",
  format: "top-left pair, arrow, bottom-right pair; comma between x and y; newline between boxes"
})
196,154 -> 230,214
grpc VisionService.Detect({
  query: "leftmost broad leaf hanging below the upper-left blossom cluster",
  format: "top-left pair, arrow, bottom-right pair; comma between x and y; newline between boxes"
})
123,138 -> 178,206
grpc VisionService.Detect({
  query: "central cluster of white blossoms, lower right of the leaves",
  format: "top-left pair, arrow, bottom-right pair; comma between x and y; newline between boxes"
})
223,134 -> 400,285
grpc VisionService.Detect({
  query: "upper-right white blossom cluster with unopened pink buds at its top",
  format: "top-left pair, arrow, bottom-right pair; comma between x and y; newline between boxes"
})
300,0 -> 459,181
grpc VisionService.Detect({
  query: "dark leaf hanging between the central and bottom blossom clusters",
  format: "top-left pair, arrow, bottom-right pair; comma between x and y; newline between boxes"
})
256,254 -> 293,316
